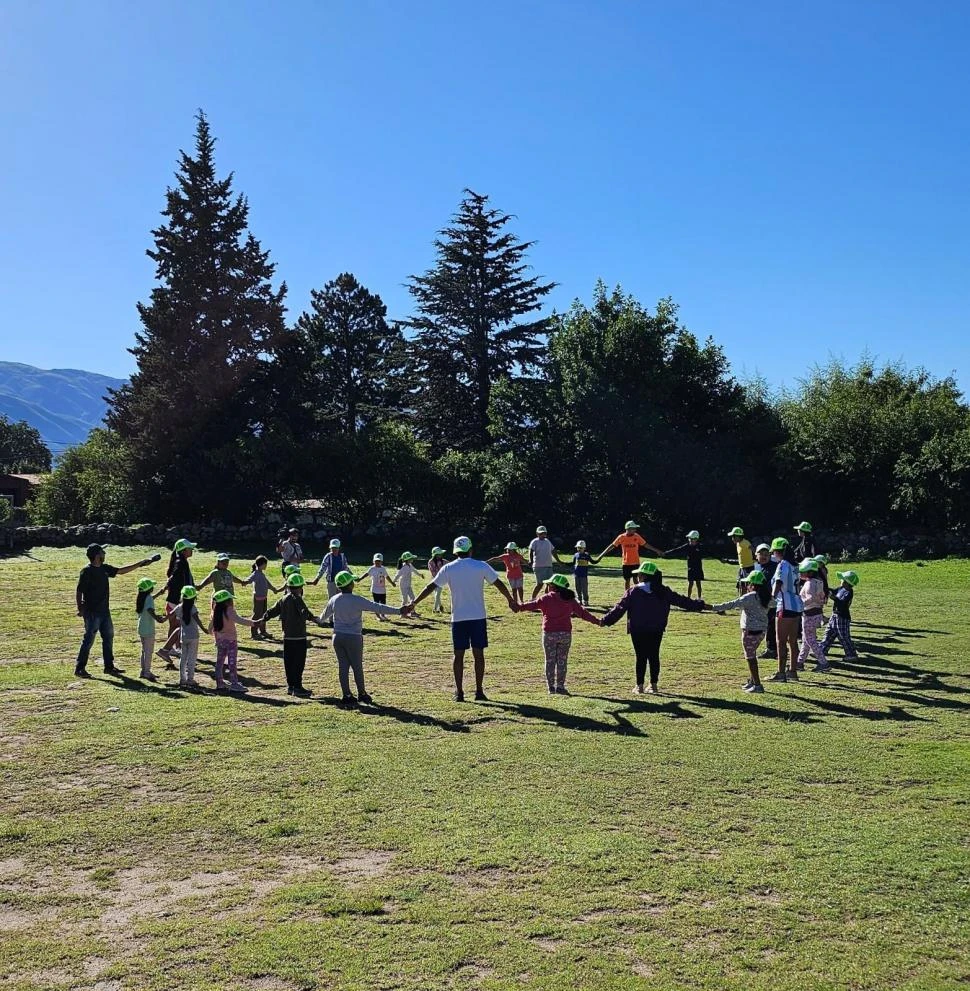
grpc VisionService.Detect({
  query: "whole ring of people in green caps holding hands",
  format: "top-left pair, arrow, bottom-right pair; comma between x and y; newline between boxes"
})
75,520 -> 859,706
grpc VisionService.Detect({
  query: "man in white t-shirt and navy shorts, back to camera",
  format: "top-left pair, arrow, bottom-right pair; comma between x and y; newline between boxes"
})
401,537 -> 515,702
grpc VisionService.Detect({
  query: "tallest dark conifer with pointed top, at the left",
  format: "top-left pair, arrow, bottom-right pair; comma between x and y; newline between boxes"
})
108,113 -> 286,522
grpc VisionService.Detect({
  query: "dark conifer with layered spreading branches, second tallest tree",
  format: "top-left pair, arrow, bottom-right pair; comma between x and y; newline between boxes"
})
404,189 -> 555,450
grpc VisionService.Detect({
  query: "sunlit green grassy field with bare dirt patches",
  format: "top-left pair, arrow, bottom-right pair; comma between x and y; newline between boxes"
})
0,548 -> 970,991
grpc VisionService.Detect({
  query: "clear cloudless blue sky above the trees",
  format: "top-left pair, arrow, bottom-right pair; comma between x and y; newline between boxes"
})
0,0 -> 970,389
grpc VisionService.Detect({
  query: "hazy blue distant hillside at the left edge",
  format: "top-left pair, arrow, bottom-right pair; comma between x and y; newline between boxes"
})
0,361 -> 124,455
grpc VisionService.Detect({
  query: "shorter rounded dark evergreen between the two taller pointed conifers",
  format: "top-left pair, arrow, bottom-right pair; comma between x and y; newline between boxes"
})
296,272 -> 404,434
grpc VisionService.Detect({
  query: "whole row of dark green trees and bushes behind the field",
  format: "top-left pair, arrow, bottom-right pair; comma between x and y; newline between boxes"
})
24,114 -> 970,544
